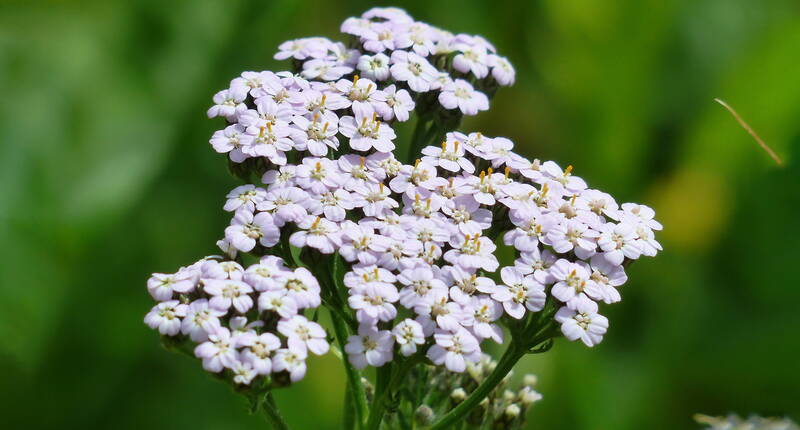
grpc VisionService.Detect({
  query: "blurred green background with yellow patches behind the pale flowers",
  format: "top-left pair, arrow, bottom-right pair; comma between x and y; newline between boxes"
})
0,0 -> 800,430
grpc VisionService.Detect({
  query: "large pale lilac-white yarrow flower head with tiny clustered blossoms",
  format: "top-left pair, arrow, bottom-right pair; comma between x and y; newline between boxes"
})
145,8 -> 661,390
